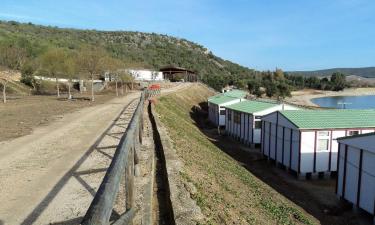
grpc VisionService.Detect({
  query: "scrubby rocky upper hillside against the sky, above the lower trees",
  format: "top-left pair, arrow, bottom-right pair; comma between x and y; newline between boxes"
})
0,21 -> 253,89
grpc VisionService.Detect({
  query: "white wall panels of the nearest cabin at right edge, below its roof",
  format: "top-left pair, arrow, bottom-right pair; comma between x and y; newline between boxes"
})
336,143 -> 375,214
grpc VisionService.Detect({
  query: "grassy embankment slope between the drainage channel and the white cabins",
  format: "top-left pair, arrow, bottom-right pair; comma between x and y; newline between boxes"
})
156,84 -> 318,224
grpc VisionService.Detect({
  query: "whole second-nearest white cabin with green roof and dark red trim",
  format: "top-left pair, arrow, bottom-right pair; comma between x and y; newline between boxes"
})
261,110 -> 375,178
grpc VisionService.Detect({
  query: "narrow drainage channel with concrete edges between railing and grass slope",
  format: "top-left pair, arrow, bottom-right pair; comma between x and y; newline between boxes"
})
133,99 -> 204,225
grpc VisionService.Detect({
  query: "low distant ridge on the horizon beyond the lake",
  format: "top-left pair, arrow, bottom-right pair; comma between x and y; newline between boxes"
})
288,67 -> 375,78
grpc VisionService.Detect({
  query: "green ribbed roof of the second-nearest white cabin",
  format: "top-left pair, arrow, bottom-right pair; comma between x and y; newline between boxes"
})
280,109 -> 375,129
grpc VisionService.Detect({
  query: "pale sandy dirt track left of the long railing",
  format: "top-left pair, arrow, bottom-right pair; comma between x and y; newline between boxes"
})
0,84 -> 189,225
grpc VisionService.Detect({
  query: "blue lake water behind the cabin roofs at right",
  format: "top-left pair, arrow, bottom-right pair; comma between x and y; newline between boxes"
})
311,95 -> 375,109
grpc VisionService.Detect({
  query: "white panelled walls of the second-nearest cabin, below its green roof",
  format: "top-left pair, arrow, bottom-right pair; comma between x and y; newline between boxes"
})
262,112 -> 373,173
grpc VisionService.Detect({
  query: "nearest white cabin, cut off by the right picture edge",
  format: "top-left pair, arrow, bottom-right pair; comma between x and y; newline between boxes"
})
336,133 -> 375,221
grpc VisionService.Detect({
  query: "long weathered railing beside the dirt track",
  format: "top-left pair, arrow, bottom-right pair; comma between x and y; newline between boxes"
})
81,92 -> 146,225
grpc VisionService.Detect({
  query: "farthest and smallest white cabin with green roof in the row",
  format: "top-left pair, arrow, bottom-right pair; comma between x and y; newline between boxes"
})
208,90 -> 246,126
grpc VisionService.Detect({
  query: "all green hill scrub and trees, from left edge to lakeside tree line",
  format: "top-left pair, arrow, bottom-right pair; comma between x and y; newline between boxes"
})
0,21 -> 360,99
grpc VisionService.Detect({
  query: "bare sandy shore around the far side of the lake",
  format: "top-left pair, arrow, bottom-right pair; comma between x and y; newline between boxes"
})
286,88 -> 375,107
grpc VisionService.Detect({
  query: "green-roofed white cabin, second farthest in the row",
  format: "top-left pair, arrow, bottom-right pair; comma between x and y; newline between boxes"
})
225,100 -> 298,145
